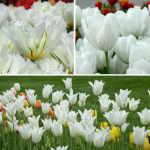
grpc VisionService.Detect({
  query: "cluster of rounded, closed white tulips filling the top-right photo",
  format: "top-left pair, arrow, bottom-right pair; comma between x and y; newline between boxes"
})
75,6 -> 150,74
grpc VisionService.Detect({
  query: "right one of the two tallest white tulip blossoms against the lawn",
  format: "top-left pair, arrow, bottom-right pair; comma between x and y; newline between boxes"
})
89,80 -> 105,96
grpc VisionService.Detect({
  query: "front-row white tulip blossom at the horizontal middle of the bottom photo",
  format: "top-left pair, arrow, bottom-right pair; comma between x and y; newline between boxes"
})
68,121 -> 83,138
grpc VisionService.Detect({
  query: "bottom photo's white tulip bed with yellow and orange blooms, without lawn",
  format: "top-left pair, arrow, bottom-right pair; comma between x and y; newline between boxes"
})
0,78 -> 150,150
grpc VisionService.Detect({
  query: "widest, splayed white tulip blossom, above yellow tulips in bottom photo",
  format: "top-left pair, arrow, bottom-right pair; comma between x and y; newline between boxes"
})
104,109 -> 128,126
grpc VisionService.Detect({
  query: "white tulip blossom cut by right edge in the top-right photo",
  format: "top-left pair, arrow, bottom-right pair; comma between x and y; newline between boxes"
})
116,6 -> 150,37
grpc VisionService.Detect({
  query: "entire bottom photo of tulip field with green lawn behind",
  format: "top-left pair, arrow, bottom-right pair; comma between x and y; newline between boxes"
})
0,76 -> 150,150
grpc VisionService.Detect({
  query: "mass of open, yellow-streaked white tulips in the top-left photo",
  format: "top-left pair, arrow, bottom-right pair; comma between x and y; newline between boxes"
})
0,1 -> 74,74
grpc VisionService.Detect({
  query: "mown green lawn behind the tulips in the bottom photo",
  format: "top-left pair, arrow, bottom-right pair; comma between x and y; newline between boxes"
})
0,76 -> 150,141
